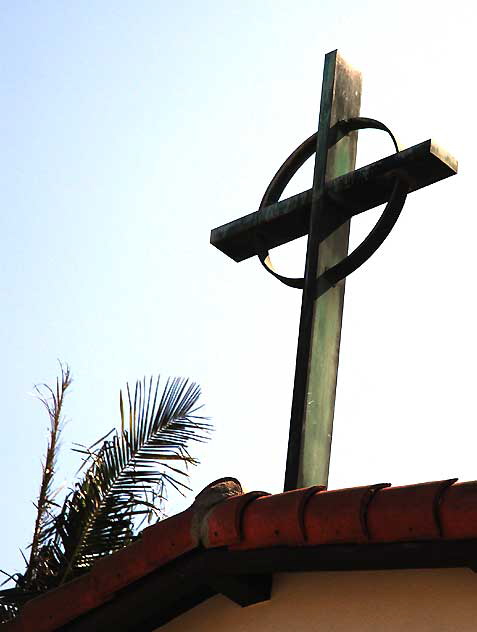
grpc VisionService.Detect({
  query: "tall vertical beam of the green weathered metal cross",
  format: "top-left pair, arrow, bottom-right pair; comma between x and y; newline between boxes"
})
284,51 -> 361,491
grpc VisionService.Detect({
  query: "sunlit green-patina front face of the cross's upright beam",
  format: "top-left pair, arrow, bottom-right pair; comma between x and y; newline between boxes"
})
297,51 -> 361,487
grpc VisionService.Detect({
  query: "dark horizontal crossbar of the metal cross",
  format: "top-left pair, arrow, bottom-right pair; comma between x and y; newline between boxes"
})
210,140 -> 457,262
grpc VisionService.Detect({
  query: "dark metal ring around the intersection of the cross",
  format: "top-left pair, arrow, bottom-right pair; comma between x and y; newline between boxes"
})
255,117 -> 409,297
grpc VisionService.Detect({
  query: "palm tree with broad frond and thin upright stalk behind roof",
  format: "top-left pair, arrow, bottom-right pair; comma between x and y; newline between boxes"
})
0,367 -> 211,623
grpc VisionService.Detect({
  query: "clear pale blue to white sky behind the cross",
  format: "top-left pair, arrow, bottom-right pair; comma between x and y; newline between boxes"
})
0,0 -> 477,571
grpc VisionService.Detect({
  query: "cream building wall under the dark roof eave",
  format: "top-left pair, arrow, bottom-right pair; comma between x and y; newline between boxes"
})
160,569 -> 477,632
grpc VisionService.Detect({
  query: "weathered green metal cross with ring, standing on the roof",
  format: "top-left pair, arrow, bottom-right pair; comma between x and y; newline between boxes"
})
210,51 -> 457,491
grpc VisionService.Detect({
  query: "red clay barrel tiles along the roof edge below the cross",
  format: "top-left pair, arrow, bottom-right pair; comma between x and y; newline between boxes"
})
4,479 -> 477,632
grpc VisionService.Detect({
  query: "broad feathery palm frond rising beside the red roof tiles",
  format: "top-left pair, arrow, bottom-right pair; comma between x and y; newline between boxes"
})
54,378 -> 210,582
